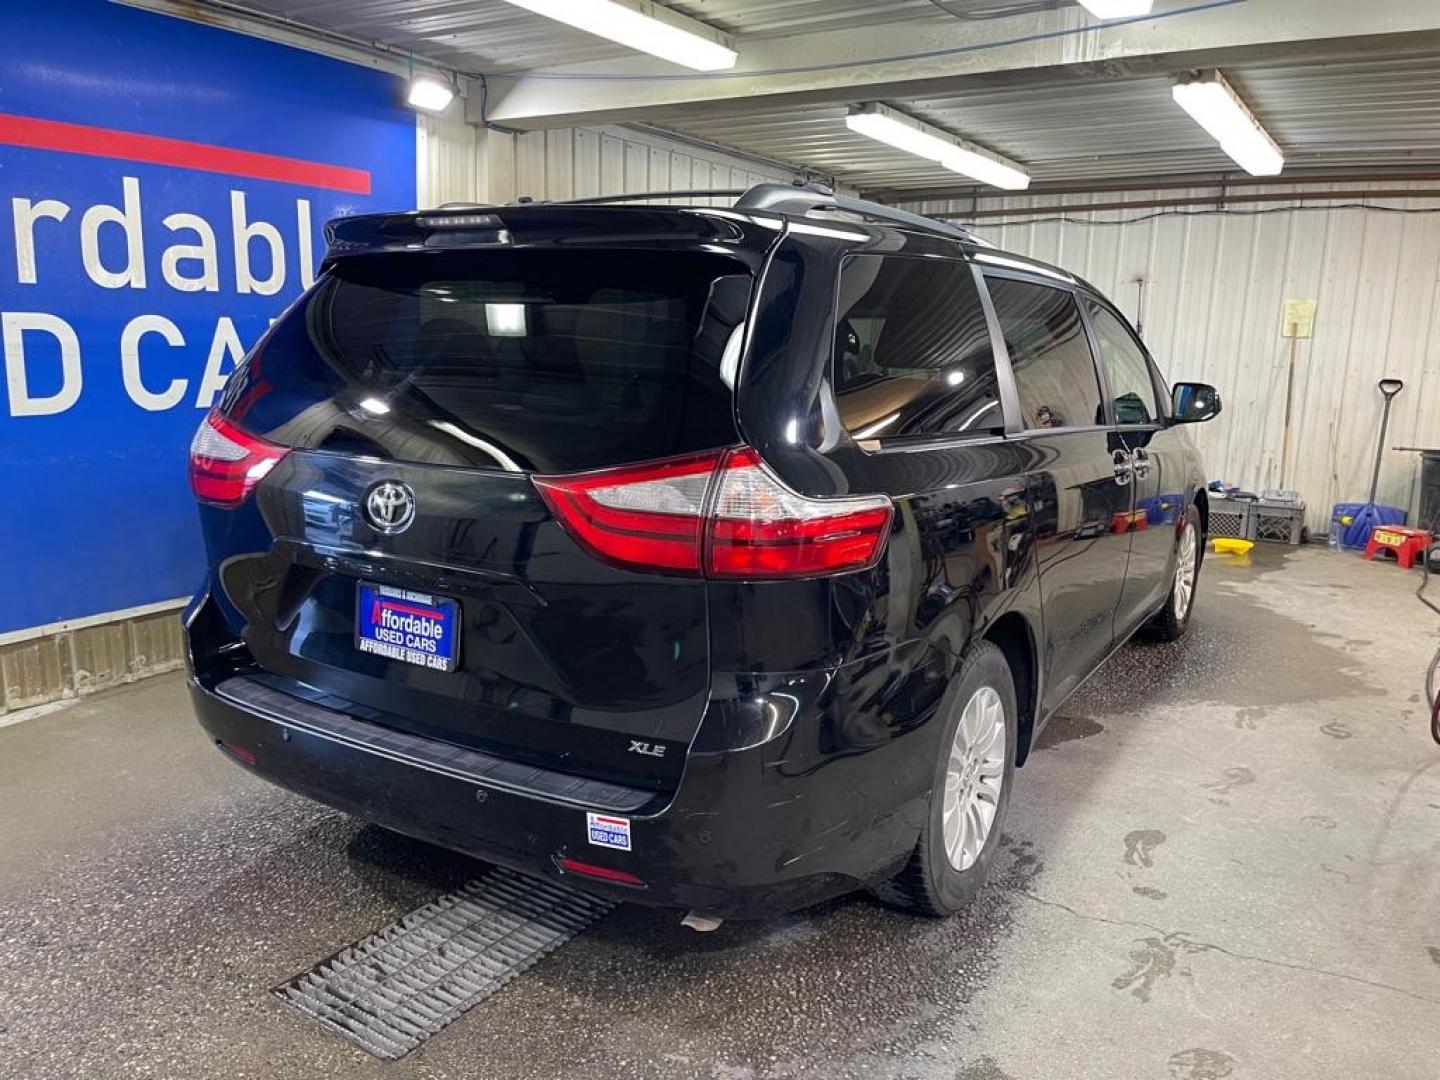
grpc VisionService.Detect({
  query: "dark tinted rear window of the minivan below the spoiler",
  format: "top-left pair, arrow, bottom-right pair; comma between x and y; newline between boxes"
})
225,249 -> 752,472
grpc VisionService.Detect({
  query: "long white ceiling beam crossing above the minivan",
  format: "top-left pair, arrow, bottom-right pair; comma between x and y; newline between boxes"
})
471,0 -> 1440,128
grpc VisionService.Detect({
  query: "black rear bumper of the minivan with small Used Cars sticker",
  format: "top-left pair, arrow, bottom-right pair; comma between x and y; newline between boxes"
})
190,675 -> 933,917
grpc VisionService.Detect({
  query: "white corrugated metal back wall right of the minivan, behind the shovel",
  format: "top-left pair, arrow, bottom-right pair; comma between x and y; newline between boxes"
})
906,191 -> 1440,534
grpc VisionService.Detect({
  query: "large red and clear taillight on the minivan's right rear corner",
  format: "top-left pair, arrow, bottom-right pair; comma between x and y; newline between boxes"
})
534,446 -> 891,579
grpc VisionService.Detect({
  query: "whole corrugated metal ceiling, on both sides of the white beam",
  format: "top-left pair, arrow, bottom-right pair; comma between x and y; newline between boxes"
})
194,0 -> 1440,190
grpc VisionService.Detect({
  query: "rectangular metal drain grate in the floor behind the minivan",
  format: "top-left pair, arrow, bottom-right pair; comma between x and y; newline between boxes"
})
275,867 -> 613,1060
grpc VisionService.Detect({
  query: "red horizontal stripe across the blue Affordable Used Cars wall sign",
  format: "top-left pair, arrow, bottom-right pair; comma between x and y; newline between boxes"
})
0,112 -> 370,194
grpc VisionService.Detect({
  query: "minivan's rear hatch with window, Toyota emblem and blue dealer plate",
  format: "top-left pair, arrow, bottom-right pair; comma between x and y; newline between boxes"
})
203,234 -> 755,789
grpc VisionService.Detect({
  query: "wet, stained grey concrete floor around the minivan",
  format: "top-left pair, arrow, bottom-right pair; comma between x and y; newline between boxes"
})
0,549 -> 1440,1080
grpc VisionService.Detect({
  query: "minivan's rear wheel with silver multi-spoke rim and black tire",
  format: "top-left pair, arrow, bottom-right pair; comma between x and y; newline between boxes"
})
874,641 -> 1018,919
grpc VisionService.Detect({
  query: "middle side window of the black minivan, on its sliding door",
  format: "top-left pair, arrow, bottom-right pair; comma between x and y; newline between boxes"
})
986,278 -> 1104,428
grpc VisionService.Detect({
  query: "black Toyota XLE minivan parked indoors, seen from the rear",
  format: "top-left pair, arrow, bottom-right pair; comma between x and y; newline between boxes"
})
184,184 -> 1220,917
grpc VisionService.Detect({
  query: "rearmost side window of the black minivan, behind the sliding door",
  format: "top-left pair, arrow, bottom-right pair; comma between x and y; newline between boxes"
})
834,255 -> 1005,439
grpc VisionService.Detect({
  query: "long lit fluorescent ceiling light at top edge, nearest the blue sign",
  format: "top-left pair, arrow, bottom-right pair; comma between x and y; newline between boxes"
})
510,0 -> 739,71
